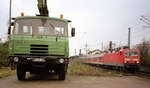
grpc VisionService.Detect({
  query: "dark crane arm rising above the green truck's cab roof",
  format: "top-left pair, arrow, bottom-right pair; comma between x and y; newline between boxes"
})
37,0 -> 49,16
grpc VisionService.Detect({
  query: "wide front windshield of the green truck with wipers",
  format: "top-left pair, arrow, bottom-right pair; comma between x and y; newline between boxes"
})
13,19 -> 67,36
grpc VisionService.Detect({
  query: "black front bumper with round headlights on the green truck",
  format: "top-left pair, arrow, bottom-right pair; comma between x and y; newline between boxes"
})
9,55 -> 69,70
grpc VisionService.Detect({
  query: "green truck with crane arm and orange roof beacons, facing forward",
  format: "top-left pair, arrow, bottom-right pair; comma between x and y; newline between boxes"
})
8,0 -> 75,80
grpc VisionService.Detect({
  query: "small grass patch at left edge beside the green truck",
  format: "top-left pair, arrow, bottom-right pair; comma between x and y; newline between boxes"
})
0,67 -> 16,78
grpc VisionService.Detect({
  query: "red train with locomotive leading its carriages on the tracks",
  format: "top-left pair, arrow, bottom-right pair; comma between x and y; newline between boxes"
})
84,49 -> 140,72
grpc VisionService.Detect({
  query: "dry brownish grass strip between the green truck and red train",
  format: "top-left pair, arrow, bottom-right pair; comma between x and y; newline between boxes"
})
67,59 -> 123,77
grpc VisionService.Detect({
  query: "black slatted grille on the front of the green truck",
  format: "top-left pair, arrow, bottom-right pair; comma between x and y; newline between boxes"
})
30,44 -> 48,54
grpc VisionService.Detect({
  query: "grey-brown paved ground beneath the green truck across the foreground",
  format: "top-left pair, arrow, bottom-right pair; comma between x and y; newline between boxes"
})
0,75 -> 150,88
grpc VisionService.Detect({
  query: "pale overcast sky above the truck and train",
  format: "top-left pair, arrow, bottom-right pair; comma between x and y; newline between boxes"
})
0,0 -> 150,55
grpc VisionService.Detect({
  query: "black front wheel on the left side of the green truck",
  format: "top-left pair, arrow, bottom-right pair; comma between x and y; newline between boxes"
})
17,65 -> 26,80
